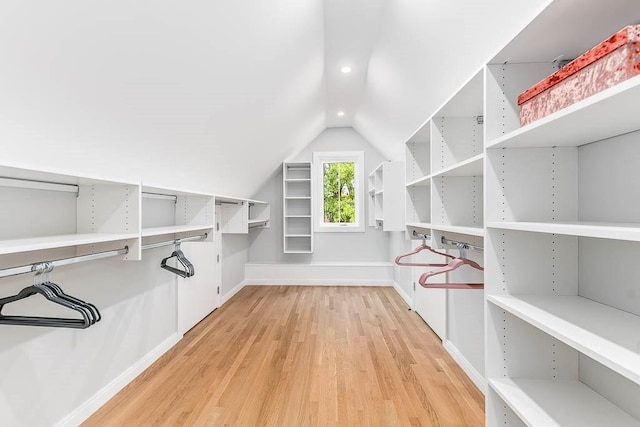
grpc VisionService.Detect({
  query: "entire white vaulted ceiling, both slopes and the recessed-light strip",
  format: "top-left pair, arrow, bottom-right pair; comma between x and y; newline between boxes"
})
0,0 -> 548,196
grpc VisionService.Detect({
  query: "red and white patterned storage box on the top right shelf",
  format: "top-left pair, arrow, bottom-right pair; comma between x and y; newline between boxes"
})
518,25 -> 640,126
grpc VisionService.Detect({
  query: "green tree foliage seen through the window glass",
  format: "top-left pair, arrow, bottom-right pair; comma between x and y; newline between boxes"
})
322,162 -> 356,223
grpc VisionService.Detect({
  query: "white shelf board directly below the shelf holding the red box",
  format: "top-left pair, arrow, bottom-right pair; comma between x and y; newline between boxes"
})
487,221 -> 640,242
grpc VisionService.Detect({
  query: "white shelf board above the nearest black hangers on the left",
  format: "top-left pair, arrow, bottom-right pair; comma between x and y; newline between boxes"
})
0,233 -> 139,255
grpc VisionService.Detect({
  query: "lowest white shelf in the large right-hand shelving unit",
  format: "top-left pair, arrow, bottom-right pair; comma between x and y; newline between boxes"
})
489,378 -> 640,427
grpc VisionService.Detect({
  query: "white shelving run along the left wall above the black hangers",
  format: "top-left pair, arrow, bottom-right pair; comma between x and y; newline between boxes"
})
0,165 -> 269,265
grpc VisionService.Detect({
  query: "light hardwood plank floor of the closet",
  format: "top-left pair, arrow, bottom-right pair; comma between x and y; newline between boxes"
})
84,286 -> 484,427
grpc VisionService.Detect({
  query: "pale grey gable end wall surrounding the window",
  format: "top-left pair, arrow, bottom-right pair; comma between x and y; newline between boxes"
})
249,128 -> 389,263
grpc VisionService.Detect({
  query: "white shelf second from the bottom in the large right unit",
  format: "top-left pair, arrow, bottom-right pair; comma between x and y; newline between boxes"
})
488,295 -> 640,384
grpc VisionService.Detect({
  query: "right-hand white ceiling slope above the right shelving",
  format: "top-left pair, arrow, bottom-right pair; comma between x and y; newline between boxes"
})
354,0 -> 560,160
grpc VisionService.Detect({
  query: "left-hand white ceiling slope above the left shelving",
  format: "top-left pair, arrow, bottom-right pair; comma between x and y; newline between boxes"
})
0,0 -> 326,197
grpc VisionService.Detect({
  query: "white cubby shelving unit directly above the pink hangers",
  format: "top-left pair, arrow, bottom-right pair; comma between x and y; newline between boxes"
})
405,70 -> 484,242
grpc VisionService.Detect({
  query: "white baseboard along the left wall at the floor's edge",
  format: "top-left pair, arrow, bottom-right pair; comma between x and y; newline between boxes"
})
55,332 -> 182,427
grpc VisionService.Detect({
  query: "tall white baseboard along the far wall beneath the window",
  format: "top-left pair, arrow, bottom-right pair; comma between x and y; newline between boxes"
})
244,262 -> 394,286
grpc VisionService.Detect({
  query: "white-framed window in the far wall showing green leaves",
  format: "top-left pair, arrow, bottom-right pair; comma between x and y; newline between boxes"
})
313,151 -> 364,232
